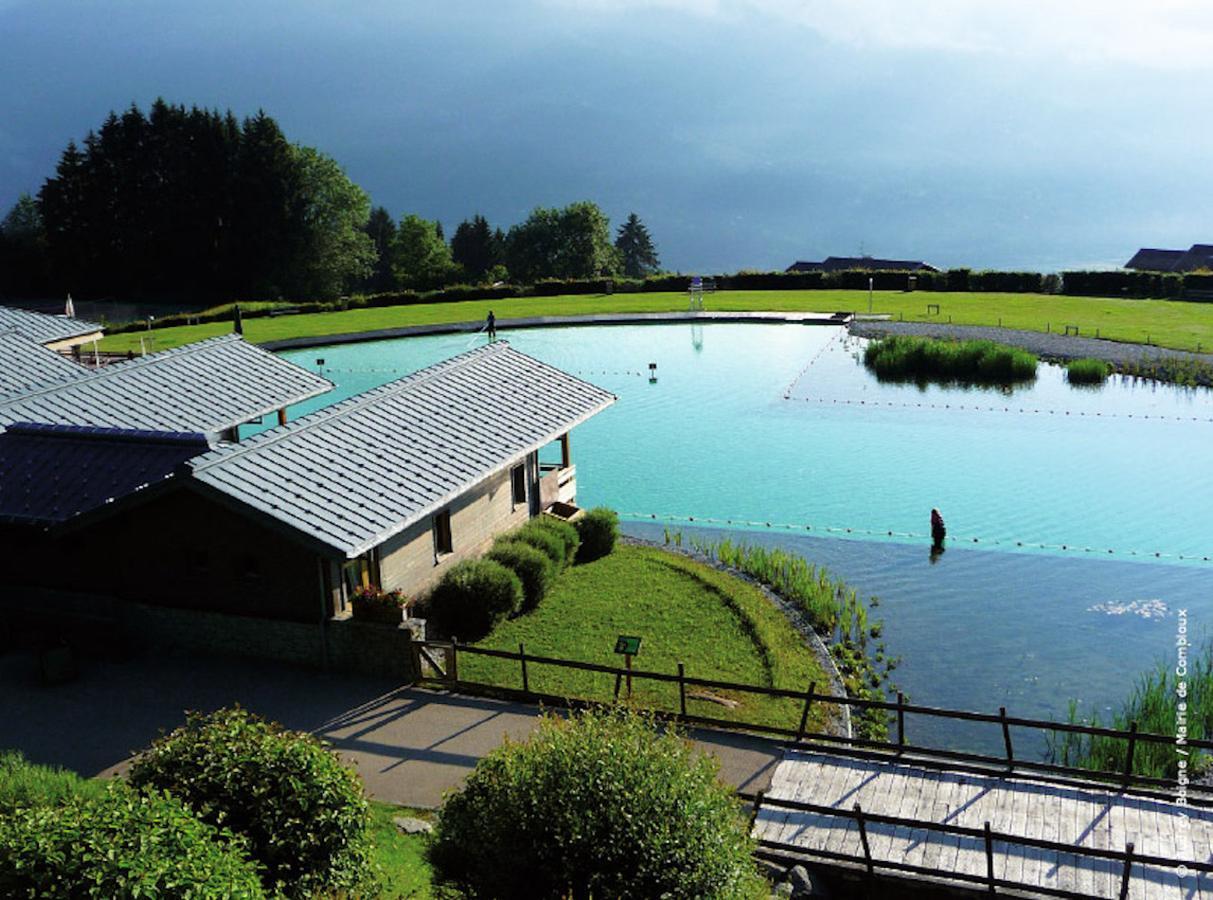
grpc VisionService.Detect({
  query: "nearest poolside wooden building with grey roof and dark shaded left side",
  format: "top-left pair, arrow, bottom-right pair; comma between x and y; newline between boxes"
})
0,342 -> 615,633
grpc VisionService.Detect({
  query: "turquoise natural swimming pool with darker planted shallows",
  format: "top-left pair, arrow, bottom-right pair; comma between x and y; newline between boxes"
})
277,324 -> 1213,745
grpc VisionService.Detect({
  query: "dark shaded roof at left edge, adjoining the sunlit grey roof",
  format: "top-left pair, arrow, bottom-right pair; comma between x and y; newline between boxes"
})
0,423 -> 210,525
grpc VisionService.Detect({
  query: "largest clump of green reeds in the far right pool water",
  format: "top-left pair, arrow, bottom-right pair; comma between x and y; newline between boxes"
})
864,335 -> 1037,385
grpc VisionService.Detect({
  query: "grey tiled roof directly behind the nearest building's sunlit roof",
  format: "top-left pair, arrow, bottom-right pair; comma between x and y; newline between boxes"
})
0,335 -> 332,435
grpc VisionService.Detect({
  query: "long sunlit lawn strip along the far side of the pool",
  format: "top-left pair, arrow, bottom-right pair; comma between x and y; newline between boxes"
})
101,291 -> 1213,352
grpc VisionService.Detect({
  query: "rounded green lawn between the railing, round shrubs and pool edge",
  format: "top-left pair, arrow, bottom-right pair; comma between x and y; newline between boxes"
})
459,545 -> 826,728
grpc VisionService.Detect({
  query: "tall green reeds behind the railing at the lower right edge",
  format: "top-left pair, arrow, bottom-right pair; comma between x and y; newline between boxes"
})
1048,642 -> 1213,779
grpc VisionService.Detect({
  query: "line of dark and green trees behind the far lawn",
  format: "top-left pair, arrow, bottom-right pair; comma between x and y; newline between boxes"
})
0,99 -> 660,301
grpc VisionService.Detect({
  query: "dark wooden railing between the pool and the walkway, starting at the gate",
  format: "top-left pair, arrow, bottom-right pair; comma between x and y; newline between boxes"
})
414,639 -> 1213,805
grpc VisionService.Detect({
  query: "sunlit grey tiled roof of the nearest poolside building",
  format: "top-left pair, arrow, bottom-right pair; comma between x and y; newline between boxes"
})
190,341 -> 615,558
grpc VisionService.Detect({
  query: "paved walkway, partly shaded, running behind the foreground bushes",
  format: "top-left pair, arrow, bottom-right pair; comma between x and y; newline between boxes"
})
0,654 -> 782,808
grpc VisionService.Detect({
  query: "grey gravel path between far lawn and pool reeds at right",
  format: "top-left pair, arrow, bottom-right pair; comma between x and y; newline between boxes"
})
850,320 -> 1213,365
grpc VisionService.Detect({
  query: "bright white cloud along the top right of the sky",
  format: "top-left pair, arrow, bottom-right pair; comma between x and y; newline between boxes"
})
548,0 -> 1213,69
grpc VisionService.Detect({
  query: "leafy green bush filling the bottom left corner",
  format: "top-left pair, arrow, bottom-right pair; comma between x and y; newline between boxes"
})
0,782 -> 263,900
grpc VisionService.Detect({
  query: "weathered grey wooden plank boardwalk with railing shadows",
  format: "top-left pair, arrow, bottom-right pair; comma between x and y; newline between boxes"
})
754,750 -> 1213,900
